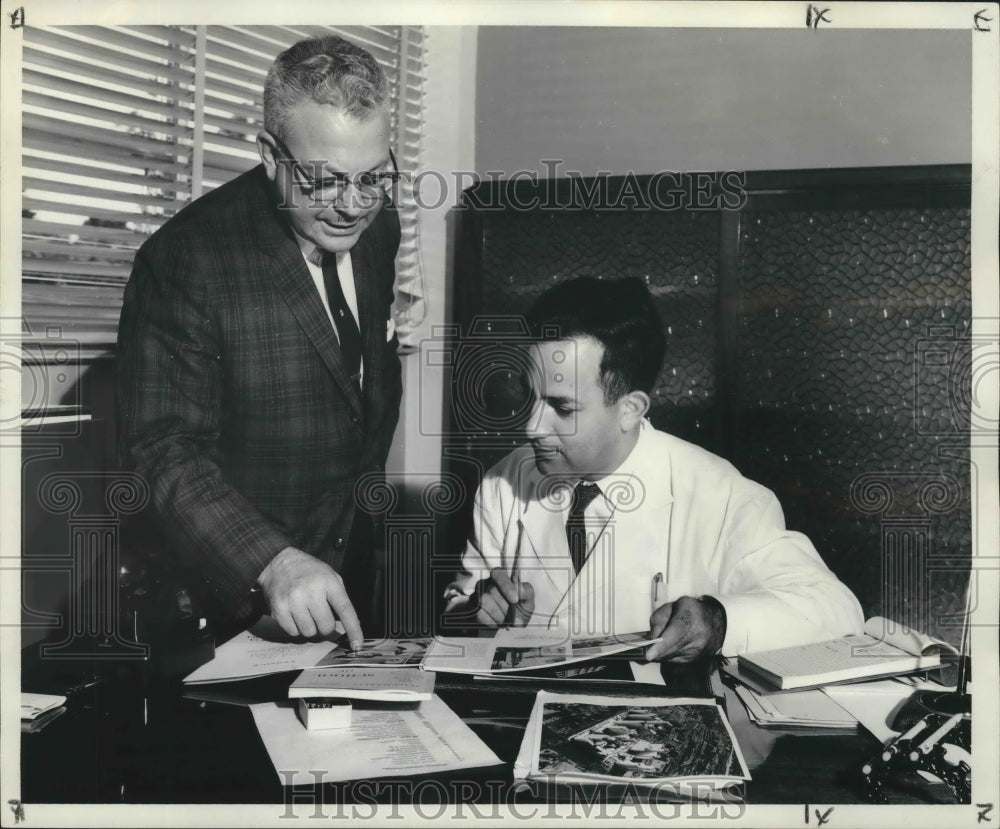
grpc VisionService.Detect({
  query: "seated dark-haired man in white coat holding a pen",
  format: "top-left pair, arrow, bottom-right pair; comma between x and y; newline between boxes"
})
447,278 -> 864,662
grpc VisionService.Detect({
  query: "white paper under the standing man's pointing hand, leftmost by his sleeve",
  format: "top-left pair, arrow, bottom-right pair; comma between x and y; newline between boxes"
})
184,616 -> 342,684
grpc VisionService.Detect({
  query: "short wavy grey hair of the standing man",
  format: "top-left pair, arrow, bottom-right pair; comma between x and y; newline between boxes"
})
264,35 -> 389,140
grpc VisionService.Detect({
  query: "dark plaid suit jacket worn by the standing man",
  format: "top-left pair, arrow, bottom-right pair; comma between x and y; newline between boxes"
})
117,167 -> 401,618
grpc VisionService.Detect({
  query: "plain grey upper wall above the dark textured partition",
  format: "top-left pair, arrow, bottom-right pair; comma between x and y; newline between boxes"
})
476,27 -> 971,176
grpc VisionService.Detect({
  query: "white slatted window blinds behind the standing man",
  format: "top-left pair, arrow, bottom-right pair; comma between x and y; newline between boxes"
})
22,26 -> 424,356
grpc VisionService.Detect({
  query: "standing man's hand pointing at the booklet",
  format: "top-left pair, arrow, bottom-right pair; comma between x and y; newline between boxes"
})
257,547 -> 364,650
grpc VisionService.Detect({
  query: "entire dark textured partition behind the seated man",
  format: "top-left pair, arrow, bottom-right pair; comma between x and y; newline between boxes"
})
444,167 -> 975,643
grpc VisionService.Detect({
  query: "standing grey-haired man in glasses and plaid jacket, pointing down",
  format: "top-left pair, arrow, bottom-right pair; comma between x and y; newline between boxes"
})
118,36 -> 401,644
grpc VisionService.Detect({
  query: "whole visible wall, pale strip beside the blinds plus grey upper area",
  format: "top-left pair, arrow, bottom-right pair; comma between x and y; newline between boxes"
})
388,26 -> 971,488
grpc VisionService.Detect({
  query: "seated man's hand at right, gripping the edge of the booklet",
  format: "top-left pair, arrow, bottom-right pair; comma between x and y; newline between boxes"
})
646,596 -> 726,662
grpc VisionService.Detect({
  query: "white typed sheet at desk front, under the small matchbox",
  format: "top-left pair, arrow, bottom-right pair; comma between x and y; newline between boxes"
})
250,695 -> 500,786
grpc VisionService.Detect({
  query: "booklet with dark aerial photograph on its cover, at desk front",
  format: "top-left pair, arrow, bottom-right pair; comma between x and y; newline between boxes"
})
514,691 -> 750,799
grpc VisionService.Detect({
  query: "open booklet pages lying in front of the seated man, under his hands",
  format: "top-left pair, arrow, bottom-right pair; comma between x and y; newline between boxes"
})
420,628 -> 660,674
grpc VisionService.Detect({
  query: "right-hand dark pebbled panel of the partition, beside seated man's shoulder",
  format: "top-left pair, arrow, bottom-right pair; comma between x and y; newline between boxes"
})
729,207 -> 972,641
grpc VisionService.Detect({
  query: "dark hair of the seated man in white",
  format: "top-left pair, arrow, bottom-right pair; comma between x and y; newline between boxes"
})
527,277 -> 666,405
